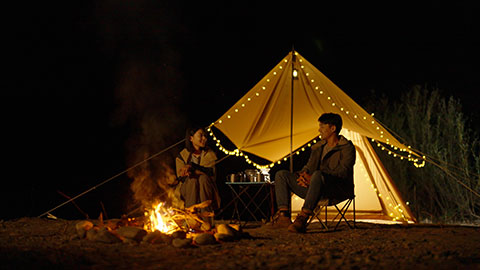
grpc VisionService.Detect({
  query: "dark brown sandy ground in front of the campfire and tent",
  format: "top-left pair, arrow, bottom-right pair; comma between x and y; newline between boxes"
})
0,218 -> 480,270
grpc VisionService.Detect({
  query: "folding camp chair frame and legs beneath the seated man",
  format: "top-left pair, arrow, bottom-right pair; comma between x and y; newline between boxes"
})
307,195 -> 356,231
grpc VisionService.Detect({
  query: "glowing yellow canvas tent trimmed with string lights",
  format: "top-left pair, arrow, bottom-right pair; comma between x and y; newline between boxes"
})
209,51 -> 421,222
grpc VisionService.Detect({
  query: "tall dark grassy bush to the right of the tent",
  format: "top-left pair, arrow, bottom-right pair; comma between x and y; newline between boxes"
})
365,86 -> 480,223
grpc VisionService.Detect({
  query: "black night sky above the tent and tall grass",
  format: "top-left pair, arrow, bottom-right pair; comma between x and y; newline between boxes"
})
0,0 -> 480,218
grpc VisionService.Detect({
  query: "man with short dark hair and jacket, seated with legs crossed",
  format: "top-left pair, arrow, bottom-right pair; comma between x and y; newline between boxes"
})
274,113 -> 355,232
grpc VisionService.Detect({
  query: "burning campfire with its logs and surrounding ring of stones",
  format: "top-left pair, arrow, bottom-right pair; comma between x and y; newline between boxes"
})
76,198 -> 248,248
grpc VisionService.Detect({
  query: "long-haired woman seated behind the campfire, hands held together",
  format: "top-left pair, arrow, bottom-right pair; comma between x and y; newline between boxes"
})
176,128 -> 220,225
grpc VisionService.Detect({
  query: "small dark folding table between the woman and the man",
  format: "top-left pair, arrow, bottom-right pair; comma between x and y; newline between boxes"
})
219,182 -> 275,226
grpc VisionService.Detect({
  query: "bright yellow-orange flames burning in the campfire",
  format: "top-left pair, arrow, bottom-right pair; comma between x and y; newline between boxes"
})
145,202 -> 179,234
